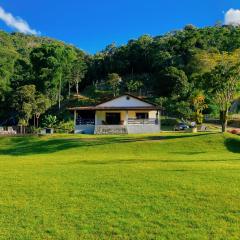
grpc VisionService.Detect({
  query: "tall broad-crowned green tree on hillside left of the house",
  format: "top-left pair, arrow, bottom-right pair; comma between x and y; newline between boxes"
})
30,44 -> 76,109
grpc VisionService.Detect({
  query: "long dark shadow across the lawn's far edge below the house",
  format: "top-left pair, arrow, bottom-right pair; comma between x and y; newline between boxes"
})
0,133 -> 218,156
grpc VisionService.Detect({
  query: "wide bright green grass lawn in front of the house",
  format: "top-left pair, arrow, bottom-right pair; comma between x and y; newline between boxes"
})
0,133 -> 240,240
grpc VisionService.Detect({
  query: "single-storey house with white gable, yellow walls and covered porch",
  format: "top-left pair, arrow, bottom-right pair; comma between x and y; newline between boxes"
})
69,94 -> 160,134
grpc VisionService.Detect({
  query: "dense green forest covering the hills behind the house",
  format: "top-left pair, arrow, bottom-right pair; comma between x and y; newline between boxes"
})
0,25 -> 240,132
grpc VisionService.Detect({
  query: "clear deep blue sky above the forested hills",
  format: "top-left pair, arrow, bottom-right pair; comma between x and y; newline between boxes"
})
0,0 -> 240,53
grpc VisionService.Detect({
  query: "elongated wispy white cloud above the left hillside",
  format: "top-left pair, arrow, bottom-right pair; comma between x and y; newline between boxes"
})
0,6 -> 39,35
